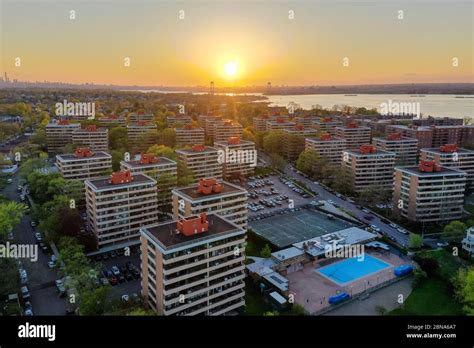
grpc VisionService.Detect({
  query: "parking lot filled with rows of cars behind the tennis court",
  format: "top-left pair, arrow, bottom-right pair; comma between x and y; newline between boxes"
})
246,175 -> 314,222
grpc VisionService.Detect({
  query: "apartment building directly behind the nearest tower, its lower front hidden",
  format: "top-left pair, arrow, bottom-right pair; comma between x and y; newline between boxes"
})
173,178 -> 247,228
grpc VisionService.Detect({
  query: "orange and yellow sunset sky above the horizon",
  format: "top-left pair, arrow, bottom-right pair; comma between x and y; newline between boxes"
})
0,0 -> 474,86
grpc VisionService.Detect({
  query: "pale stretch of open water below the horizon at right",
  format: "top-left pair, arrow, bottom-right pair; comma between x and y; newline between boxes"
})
268,94 -> 474,118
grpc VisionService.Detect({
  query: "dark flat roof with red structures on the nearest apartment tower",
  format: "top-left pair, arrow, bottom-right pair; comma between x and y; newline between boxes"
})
141,213 -> 242,250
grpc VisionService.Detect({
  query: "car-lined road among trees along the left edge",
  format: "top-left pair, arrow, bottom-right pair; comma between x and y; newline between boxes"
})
3,176 -> 66,315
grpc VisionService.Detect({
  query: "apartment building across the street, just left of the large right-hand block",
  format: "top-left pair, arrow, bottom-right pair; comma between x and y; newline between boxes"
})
341,144 -> 395,192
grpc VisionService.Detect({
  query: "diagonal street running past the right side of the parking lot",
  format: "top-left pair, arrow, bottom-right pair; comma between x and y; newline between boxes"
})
258,152 -> 408,247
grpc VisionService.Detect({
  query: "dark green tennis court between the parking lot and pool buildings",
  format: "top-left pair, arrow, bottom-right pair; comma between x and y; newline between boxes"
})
250,209 -> 353,248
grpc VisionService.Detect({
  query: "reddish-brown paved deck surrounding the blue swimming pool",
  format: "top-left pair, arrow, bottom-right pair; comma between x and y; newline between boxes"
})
285,251 -> 408,313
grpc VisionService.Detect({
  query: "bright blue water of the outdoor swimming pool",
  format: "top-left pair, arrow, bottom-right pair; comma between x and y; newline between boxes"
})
317,254 -> 390,284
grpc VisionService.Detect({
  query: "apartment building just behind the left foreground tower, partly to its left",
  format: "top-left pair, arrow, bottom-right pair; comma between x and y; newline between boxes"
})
56,148 -> 112,180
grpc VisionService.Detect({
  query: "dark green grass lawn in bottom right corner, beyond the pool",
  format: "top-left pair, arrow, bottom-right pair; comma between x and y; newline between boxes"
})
390,278 -> 462,315
